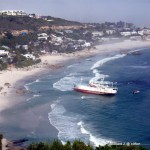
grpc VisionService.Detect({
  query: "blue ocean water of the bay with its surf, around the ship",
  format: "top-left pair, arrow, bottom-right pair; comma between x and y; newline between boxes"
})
0,48 -> 150,146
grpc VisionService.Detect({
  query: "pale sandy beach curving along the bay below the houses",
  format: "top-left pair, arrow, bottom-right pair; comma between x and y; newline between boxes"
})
0,41 -> 150,115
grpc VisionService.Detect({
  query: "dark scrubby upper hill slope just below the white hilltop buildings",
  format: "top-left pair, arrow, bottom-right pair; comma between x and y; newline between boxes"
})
0,16 -> 81,32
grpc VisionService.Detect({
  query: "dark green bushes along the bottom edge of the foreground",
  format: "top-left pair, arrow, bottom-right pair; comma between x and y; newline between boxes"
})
27,140 -> 148,150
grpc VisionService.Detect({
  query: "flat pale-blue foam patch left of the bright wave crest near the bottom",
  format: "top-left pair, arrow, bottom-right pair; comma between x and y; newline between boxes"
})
48,103 -> 86,142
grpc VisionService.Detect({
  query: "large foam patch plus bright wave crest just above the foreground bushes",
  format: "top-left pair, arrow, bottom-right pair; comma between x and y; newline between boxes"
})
48,101 -> 114,146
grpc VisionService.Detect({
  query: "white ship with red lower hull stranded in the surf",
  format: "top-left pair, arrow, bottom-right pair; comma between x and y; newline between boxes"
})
74,78 -> 118,95
